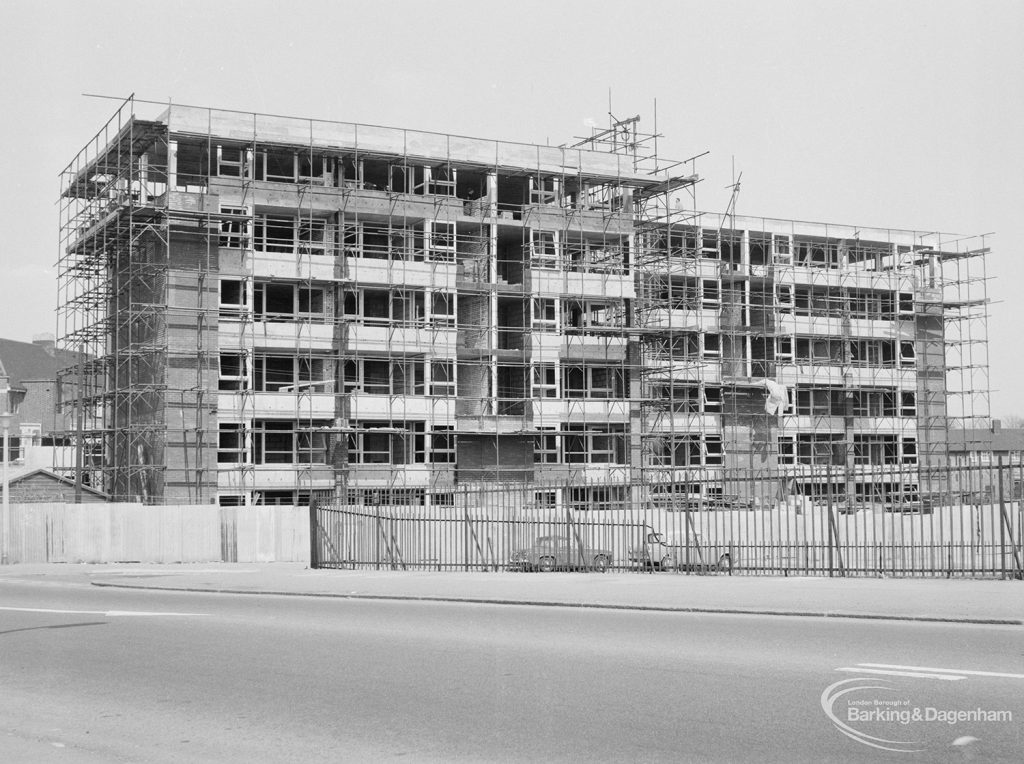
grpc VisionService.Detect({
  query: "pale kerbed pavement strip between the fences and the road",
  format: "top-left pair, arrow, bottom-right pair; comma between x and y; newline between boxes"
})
0,562 -> 1024,626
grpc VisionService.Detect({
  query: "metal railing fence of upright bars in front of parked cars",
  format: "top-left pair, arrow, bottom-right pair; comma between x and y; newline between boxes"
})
310,464 -> 1024,579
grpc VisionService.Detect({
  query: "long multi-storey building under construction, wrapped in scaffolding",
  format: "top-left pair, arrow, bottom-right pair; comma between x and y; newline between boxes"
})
55,99 -> 989,507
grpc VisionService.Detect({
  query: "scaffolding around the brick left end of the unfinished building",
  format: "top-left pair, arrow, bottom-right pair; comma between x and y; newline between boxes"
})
55,98 -> 219,502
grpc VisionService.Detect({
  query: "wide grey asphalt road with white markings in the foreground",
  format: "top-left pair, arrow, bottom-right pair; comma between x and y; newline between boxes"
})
0,581 -> 1024,763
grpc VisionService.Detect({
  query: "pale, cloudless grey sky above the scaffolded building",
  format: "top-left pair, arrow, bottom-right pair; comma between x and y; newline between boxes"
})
0,0 -> 1024,417
